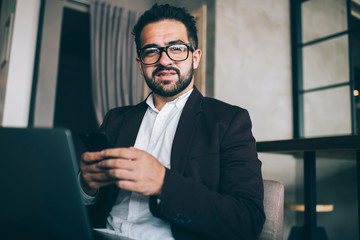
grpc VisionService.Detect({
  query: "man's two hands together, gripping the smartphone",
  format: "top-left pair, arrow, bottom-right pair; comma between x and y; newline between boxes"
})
80,147 -> 165,196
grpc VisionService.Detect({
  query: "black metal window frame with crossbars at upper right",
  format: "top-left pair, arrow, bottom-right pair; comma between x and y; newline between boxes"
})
290,0 -> 358,138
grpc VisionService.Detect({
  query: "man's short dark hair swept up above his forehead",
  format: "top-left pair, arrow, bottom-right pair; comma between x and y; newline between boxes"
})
132,4 -> 198,50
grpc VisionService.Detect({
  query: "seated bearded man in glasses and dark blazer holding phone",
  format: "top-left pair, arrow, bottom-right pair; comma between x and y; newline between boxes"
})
80,5 -> 265,240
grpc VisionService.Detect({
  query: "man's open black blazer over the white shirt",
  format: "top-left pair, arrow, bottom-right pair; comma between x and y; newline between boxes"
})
88,88 -> 265,240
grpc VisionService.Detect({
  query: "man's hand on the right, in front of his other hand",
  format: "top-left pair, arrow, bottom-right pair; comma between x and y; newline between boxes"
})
98,147 -> 165,196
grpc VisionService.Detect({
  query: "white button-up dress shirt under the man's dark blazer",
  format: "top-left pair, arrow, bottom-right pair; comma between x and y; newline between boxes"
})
83,90 -> 192,240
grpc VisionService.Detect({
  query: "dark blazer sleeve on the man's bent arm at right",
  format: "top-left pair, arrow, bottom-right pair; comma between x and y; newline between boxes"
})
150,108 -> 265,240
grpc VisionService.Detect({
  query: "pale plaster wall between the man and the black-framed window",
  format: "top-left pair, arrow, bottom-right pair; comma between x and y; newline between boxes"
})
214,0 -> 297,237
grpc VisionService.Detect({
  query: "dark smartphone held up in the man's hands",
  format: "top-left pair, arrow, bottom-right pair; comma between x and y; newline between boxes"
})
80,131 -> 114,152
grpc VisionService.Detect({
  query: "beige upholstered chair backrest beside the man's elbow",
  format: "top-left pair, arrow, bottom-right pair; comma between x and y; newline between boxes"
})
259,180 -> 284,240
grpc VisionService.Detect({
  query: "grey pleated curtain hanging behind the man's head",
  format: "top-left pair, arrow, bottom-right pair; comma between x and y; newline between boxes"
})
90,0 -> 144,124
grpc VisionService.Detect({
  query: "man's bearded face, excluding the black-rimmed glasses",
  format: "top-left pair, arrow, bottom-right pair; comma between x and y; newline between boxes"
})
136,20 -> 201,97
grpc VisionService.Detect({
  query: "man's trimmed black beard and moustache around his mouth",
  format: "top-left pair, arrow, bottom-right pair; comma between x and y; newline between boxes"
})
144,65 -> 194,97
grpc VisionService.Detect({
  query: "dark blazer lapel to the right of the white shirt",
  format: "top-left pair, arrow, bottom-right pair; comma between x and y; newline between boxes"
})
170,87 -> 203,174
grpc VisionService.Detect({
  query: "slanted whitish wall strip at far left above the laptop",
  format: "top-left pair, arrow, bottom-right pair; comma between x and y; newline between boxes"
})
2,0 -> 40,127
